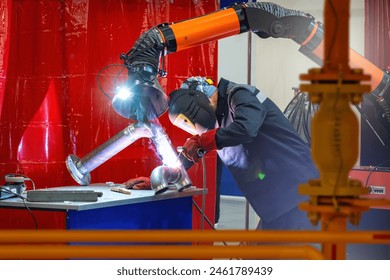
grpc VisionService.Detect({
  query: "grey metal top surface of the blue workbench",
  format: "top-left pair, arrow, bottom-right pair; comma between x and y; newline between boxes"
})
0,184 -> 203,211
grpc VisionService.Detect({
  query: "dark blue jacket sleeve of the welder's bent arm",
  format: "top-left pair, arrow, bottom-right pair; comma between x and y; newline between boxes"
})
216,89 -> 267,149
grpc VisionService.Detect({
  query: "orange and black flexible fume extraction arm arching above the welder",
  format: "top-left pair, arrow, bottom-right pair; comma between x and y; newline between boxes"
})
120,2 -> 390,132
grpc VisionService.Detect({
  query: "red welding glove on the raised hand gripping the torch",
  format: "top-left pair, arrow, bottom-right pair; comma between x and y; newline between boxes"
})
183,128 -> 218,163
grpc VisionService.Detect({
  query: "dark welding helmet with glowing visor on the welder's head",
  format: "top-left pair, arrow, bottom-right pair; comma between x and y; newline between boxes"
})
168,77 -> 217,135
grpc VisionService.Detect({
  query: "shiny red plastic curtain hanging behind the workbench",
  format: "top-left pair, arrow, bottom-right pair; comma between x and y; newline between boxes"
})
0,0 -> 218,228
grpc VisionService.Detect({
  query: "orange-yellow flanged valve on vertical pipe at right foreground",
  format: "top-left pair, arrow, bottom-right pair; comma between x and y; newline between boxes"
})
300,1 -> 370,217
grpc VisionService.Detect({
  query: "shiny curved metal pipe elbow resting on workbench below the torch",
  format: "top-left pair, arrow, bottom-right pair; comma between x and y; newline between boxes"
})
150,165 -> 181,194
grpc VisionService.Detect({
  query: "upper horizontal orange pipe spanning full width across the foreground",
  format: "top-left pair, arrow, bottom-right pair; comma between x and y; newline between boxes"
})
0,230 -> 390,244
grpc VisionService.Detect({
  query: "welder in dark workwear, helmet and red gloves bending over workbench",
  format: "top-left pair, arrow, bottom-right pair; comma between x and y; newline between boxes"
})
127,77 -> 319,230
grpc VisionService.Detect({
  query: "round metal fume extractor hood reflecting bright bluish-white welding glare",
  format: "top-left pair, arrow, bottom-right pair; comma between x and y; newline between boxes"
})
112,66 -> 168,122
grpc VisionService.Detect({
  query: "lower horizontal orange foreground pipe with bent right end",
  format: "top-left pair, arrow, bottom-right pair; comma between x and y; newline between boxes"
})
0,245 -> 324,260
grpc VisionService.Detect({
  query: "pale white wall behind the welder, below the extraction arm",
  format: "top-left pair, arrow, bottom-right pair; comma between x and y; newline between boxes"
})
218,0 -> 364,110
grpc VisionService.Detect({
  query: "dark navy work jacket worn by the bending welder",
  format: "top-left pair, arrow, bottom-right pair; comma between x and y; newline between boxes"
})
216,78 -> 319,222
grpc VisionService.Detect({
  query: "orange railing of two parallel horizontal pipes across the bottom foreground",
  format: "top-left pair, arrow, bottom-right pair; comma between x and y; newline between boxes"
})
0,230 -> 390,259
